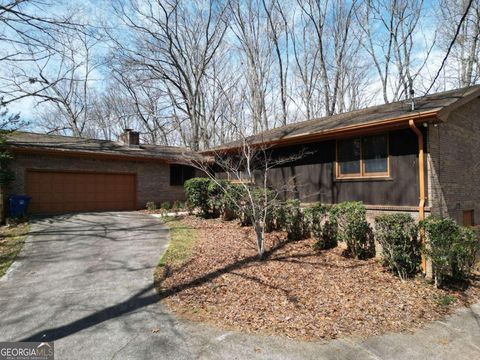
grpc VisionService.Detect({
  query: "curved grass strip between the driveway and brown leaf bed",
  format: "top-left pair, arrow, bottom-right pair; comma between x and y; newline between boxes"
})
158,217 -> 197,267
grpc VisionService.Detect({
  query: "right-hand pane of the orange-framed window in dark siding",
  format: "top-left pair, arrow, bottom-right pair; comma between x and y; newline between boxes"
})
363,135 -> 388,174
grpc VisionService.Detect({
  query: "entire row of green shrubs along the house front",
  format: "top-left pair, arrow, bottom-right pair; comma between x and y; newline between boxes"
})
185,178 -> 479,285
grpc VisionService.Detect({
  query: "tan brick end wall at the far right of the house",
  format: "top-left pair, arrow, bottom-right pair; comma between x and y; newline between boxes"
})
427,98 -> 480,224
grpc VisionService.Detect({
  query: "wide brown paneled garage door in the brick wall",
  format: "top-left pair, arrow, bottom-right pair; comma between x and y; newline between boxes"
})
26,170 -> 136,214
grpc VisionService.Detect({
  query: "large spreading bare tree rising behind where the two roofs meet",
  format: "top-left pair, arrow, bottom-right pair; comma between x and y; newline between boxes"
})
115,0 -> 231,150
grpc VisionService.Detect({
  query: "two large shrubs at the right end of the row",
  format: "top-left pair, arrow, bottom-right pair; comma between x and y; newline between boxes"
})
375,214 -> 480,286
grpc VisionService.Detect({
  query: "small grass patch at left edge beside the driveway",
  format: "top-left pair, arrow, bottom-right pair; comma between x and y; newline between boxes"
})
0,224 -> 29,277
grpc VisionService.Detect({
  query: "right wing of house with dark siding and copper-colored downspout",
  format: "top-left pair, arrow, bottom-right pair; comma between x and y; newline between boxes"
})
202,86 -> 480,225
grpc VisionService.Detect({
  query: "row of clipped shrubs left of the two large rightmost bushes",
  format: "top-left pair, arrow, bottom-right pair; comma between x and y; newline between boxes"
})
185,178 -> 375,259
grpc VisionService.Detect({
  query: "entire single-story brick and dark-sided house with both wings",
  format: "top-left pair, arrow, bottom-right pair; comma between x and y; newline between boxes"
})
3,86 -> 480,225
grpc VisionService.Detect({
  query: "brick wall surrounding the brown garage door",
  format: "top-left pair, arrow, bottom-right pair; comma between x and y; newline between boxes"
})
8,154 -> 185,209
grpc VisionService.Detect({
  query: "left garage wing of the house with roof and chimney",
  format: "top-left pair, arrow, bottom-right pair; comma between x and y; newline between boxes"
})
6,129 -> 201,214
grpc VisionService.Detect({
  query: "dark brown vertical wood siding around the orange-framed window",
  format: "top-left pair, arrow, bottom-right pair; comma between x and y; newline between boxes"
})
269,129 -> 419,207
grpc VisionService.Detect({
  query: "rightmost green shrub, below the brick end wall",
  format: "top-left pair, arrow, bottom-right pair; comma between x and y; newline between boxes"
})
421,216 -> 479,286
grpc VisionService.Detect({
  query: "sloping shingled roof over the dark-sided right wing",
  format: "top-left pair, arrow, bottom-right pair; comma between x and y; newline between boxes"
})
204,85 -> 480,154
